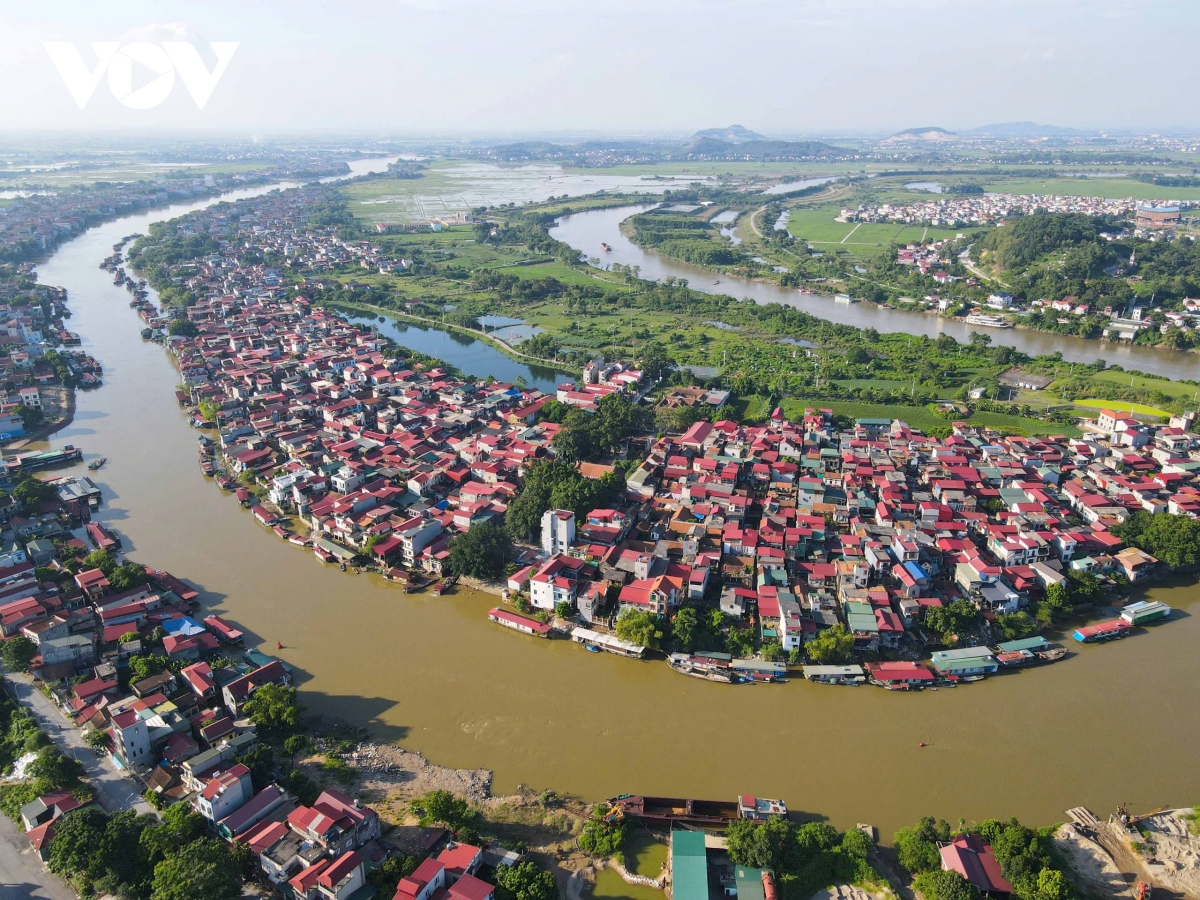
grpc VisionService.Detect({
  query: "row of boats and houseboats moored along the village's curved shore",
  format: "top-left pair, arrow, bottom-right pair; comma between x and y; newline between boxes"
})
487,600 -> 1171,691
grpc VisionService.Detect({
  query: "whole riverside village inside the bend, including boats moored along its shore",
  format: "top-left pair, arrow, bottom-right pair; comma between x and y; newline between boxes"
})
82,192 -> 1200,690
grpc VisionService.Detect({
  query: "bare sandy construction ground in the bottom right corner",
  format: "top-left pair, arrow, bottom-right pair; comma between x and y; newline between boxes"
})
1055,805 -> 1200,900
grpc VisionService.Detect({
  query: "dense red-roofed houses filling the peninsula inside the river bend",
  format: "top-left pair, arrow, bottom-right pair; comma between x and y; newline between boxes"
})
133,187 -> 1196,676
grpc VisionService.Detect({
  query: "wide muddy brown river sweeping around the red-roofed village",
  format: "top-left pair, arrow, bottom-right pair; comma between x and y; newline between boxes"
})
25,177 -> 1200,835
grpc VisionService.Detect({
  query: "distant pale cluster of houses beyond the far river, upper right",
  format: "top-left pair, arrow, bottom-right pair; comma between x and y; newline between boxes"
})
836,193 -> 1136,228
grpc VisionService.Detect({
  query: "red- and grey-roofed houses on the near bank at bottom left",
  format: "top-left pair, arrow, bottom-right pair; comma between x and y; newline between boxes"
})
0,518 -> 530,900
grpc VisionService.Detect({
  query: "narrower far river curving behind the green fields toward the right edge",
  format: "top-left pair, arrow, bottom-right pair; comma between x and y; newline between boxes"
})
550,205 -> 1200,378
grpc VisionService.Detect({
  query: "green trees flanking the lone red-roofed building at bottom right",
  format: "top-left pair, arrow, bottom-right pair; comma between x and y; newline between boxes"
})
894,816 -> 1078,900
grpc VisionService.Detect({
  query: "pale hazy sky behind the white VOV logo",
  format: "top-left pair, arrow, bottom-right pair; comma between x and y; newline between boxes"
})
0,0 -> 1200,137
